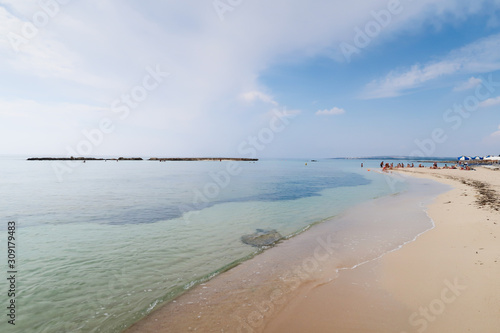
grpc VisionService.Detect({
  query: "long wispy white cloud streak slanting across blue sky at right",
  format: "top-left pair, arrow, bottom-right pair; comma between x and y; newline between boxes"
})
362,34 -> 500,99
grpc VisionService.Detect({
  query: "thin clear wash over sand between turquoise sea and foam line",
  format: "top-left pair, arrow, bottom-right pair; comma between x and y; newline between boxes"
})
125,172 -> 450,332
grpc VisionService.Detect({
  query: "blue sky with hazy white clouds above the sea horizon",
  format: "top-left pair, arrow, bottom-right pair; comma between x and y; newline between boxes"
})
0,0 -> 500,158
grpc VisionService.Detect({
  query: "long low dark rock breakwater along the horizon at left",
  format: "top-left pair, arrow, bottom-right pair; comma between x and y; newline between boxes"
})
27,157 -> 259,162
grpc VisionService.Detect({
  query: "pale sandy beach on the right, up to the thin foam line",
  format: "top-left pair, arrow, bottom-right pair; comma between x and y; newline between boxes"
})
265,168 -> 500,333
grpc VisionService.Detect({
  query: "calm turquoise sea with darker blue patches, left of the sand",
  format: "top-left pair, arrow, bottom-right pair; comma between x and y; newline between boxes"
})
0,157 -> 405,332
